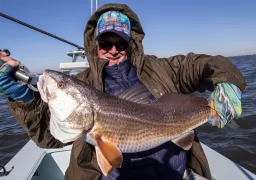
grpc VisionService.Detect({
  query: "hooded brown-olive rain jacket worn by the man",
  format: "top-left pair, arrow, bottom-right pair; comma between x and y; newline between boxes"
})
9,4 -> 246,179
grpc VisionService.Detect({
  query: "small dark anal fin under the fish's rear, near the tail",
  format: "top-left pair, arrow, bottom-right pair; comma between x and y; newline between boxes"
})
172,130 -> 195,151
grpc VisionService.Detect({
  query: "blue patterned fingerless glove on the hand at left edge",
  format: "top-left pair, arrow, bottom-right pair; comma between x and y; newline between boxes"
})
0,59 -> 33,103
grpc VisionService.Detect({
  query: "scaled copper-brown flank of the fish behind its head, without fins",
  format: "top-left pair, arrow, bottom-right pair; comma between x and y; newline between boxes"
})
85,94 -> 209,152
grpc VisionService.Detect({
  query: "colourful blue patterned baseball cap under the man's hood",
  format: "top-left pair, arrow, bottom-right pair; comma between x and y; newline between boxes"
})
96,10 -> 131,41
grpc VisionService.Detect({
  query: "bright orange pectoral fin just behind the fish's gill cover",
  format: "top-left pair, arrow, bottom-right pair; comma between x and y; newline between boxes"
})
95,135 -> 123,168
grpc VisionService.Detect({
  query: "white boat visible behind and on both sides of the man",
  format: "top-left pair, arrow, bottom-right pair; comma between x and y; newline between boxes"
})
0,50 -> 256,180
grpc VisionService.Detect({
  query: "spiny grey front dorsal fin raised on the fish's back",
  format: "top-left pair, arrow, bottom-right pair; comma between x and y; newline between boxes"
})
118,83 -> 151,104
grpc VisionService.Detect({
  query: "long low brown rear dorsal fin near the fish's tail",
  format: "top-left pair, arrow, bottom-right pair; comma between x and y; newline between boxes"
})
154,93 -> 208,107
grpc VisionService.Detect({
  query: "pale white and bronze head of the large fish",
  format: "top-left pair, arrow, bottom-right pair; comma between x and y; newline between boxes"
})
37,70 -> 93,142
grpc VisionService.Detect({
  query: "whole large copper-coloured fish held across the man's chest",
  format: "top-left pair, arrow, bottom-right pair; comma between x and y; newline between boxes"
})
38,70 -> 210,175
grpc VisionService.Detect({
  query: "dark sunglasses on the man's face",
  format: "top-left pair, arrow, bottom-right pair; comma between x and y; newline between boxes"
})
98,40 -> 129,51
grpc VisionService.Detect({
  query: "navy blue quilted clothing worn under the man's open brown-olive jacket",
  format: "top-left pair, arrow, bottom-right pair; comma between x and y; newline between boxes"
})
102,59 -> 187,180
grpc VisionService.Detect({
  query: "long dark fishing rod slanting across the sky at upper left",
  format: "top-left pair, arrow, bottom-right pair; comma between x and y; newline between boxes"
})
0,12 -> 84,50
